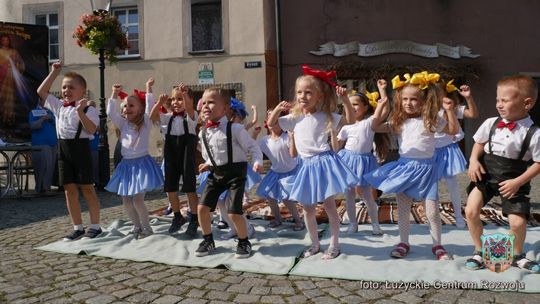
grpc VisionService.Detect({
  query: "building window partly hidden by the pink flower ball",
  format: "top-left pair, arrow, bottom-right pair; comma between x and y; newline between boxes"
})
113,7 -> 140,58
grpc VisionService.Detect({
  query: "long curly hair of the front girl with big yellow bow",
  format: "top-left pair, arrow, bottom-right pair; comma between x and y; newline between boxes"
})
390,83 -> 445,133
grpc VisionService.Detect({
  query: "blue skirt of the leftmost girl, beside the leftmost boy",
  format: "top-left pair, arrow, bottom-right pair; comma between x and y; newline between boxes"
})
105,155 -> 163,196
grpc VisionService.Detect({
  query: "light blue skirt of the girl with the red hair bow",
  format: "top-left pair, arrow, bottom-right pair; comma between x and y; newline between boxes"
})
289,151 -> 358,205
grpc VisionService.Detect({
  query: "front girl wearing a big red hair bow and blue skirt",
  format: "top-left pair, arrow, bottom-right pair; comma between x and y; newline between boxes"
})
268,65 -> 358,259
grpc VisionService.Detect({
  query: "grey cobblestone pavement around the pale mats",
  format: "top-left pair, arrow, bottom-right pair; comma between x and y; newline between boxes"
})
0,175 -> 540,304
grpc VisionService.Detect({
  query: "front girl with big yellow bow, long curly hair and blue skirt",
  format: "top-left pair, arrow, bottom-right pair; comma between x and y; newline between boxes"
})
364,72 -> 458,260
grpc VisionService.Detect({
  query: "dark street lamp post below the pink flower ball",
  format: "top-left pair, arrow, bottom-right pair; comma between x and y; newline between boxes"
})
98,48 -> 110,189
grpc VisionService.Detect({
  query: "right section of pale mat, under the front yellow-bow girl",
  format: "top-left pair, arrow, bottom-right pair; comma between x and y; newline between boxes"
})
289,224 -> 540,292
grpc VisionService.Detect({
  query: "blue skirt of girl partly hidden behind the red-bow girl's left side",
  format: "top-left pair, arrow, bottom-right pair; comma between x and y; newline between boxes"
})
256,167 -> 298,202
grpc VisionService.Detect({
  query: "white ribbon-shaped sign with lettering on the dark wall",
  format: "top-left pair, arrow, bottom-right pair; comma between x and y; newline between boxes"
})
310,40 -> 480,59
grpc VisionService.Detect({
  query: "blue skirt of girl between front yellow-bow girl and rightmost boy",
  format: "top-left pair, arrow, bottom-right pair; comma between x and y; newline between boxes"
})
433,143 -> 467,179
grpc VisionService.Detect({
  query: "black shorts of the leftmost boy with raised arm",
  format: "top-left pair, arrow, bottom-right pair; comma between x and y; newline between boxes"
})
58,138 -> 94,186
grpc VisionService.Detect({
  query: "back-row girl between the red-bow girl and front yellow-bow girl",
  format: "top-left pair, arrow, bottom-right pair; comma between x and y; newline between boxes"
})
337,79 -> 388,235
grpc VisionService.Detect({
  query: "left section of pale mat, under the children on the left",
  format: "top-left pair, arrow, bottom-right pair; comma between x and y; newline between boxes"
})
37,218 -> 309,275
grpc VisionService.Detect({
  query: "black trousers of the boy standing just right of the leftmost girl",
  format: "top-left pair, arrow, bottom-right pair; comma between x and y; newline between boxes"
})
163,134 -> 197,193
